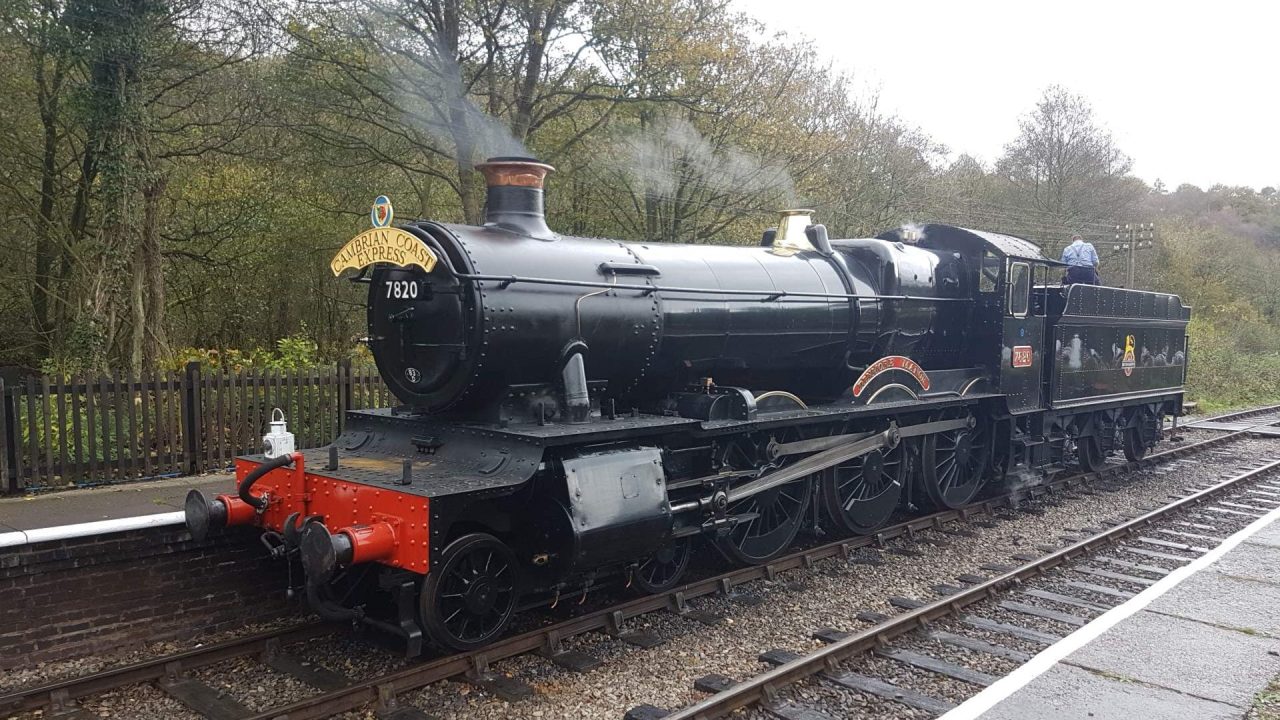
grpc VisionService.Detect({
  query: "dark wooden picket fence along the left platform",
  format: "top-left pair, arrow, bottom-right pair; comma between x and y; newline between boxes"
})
0,363 -> 393,492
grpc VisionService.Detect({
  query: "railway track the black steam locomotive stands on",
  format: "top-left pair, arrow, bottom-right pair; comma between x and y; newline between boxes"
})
0,406 -> 1280,720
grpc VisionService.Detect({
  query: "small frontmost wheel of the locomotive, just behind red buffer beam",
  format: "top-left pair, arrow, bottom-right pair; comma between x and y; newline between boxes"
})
419,533 -> 517,651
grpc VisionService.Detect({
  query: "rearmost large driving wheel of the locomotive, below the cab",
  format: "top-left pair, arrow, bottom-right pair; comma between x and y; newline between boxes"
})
920,424 -> 991,509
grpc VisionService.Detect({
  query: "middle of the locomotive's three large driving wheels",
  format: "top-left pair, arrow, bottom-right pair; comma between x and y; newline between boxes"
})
822,443 -> 906,534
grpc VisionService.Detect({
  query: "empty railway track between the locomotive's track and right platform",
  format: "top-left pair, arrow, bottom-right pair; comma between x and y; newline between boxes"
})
640,448 -> 1280,720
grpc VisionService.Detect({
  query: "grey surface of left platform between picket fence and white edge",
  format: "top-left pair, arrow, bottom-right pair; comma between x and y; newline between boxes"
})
0,474 -> 234,532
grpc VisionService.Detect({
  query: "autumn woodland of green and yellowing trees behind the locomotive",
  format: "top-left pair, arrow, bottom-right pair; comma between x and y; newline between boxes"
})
0,0 -> 1280,417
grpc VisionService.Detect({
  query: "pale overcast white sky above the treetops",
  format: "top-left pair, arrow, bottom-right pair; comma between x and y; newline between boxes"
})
735,0 -> 1280,190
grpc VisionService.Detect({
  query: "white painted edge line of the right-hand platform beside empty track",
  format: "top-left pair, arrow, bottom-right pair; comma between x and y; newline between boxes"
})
938,484 -> 1280,720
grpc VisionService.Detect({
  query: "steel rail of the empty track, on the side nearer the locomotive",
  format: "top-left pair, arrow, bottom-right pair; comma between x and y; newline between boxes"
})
663,460 -> 1280,720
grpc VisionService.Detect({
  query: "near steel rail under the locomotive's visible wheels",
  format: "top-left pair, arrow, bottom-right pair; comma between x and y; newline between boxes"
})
232,430 -> 1248,720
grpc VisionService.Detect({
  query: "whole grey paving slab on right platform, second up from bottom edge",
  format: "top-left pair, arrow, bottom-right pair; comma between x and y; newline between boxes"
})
1064,612 -> 1280,706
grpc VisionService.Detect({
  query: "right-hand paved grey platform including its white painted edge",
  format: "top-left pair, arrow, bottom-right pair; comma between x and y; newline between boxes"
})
942,491 -> 1280,720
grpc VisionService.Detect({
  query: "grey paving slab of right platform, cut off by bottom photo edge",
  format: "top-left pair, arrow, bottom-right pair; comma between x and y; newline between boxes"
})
983,665 -> 1240,720
